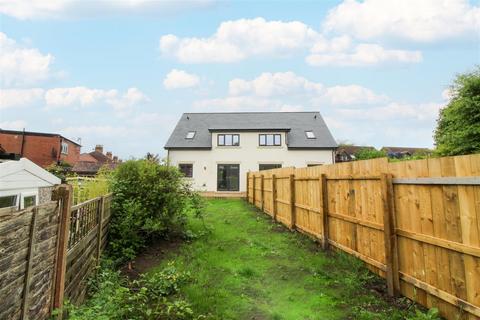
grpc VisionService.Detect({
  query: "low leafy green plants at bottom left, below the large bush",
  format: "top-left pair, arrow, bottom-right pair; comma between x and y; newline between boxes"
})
66,263 -> 202,320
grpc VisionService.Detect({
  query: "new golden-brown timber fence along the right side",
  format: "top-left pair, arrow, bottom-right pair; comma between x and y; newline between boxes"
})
247,154 -> 480,319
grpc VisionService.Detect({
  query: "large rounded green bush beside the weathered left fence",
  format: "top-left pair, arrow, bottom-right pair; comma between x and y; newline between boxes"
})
109,160 -> 201,262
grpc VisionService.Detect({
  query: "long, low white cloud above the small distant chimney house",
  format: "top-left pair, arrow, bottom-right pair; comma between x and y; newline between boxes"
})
45,87 -> 149,111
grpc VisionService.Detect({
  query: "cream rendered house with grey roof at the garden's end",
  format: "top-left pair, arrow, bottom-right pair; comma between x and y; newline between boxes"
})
165,112 -> 337,192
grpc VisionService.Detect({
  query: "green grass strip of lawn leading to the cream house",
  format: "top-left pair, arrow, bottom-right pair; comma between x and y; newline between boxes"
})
149,199 -> 426,320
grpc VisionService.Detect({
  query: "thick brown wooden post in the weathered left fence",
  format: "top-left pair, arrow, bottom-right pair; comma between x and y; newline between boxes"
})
53,184 -> 72,319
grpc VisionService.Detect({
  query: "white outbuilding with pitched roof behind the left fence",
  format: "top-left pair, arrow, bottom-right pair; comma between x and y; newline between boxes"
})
0,158 -> 61,209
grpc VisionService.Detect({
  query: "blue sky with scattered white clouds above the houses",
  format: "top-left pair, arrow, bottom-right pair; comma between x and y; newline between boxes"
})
0,0 -> 480,158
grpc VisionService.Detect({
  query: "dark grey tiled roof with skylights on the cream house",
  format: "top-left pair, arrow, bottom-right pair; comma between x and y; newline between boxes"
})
165,112 -> 337,149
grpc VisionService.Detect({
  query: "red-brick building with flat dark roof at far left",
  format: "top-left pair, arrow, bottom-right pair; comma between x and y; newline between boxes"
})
0,129 -> 81,168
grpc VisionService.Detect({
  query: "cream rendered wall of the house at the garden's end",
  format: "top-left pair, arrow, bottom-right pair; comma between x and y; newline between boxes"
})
168,132 -> 333,191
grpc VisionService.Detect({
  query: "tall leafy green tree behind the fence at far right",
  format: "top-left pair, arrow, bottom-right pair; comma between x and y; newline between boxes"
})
435,67 -> 480,155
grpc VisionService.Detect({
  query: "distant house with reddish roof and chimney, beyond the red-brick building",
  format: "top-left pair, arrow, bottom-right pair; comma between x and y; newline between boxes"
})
72,145 -> 120,177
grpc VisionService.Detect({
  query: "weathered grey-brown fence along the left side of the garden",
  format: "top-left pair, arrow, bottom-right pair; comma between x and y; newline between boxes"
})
0,185 -> 112,319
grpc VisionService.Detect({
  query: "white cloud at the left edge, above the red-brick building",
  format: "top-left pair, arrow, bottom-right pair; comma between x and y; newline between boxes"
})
0,32 -> 54,87
